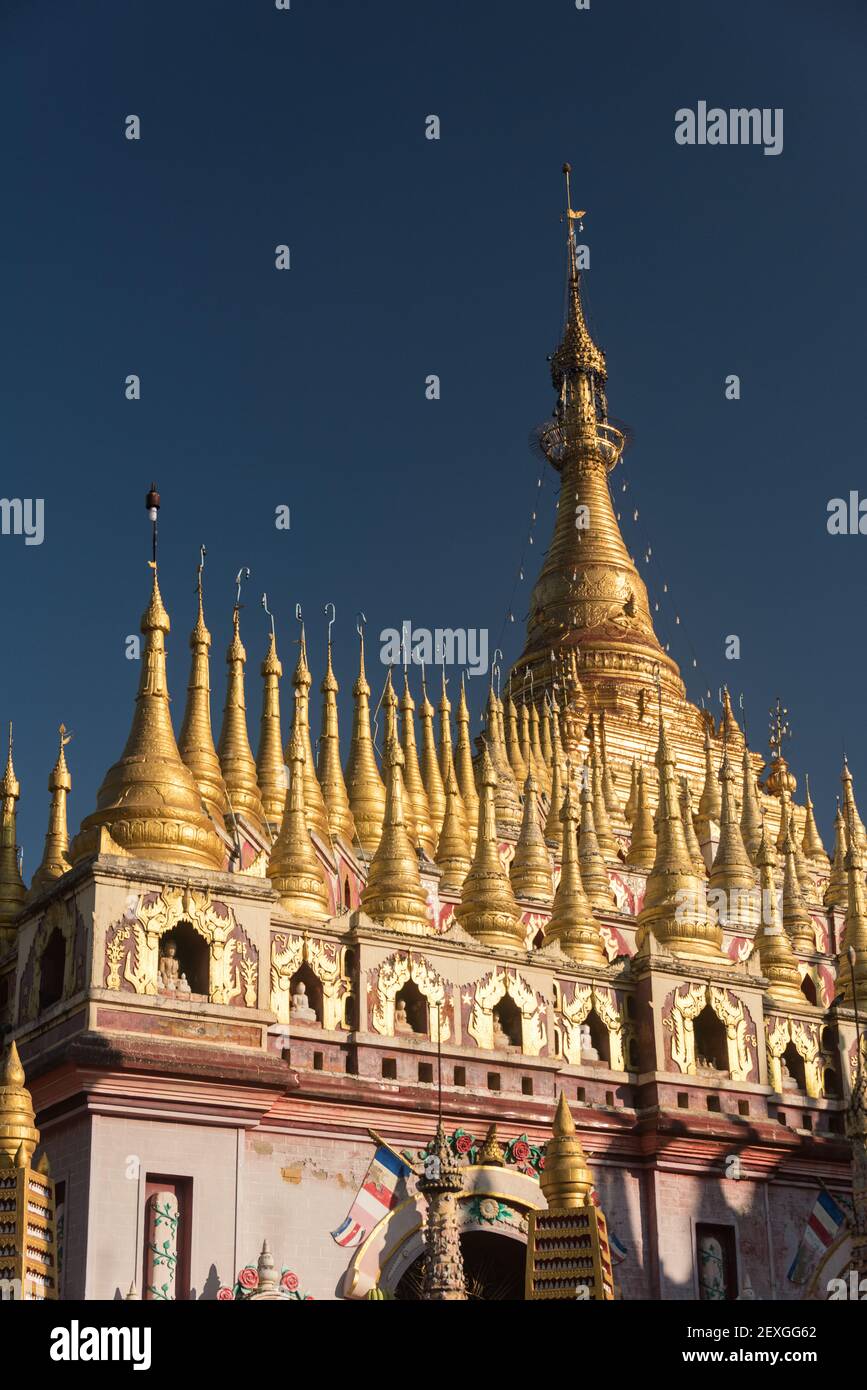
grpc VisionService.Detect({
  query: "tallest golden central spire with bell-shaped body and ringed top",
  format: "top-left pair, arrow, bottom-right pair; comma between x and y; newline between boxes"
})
515,164 -> 684,698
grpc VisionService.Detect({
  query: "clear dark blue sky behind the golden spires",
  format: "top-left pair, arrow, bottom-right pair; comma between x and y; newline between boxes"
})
0,0 -> 867,874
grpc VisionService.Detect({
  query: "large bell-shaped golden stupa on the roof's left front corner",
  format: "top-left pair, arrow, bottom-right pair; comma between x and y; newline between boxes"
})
69,567 -> 226,869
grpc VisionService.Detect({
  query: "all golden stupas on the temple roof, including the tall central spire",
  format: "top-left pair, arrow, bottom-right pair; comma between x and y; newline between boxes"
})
0,167 -> 867,988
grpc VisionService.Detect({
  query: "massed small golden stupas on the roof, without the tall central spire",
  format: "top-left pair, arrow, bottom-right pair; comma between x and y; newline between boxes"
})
0,536 -> 867,988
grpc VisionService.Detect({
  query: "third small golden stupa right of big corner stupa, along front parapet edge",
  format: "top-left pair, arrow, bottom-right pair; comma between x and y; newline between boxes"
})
454,750 -> 524,947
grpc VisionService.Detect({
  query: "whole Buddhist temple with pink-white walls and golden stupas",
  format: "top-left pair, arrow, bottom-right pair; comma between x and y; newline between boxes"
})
0,168 -> 867,1301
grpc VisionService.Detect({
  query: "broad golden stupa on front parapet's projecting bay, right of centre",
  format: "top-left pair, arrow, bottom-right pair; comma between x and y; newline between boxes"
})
636,720 -> 725,962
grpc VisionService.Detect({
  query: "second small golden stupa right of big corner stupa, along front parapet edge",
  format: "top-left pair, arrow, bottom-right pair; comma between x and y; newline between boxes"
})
361,738 -> 431,935
